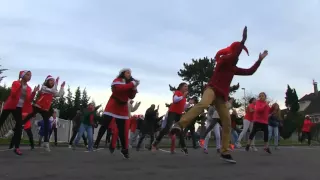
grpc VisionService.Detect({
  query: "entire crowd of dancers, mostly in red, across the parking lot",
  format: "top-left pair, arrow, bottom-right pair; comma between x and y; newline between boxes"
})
0,27 -> 314,163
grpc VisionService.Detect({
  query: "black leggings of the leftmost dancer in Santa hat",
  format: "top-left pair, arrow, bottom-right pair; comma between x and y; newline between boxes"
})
0,107 -> 22,148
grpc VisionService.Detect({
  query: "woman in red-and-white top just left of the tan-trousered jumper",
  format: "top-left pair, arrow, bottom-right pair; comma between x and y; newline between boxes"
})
152,83 -> 188,155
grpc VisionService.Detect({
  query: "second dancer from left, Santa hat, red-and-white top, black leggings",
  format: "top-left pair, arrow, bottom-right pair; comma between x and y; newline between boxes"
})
23,75 -> 65,152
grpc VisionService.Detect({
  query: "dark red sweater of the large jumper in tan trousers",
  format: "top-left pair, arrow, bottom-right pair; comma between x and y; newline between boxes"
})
208,43 -> 261,101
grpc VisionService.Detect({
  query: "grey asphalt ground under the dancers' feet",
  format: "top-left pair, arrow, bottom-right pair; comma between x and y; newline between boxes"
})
0,146 -> 320,180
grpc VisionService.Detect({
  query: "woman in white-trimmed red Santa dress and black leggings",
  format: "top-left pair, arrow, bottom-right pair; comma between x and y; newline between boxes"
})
98,68 -> 140,159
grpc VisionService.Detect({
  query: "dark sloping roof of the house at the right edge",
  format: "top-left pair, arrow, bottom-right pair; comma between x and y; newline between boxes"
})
299,92 -> 320,114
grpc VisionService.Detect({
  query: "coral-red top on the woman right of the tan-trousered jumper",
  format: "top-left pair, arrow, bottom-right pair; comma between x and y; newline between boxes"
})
253,100 -> 270,124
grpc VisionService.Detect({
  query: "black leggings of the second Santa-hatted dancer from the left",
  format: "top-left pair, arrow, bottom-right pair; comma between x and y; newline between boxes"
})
23,106 -> 50,142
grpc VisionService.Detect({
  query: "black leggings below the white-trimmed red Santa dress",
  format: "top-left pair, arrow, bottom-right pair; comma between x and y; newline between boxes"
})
94,115 -> 128,150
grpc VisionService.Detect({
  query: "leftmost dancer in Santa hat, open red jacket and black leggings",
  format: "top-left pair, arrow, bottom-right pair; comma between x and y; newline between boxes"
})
0,70 -> 39,155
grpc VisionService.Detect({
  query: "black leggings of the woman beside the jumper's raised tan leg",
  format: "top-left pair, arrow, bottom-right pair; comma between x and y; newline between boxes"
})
155,112 -> 187,148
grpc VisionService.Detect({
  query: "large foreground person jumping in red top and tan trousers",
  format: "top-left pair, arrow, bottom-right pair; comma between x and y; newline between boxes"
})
171,27 -> 268,163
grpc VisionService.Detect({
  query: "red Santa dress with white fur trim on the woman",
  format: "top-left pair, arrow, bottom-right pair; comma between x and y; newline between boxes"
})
103,78 -> 137,119
